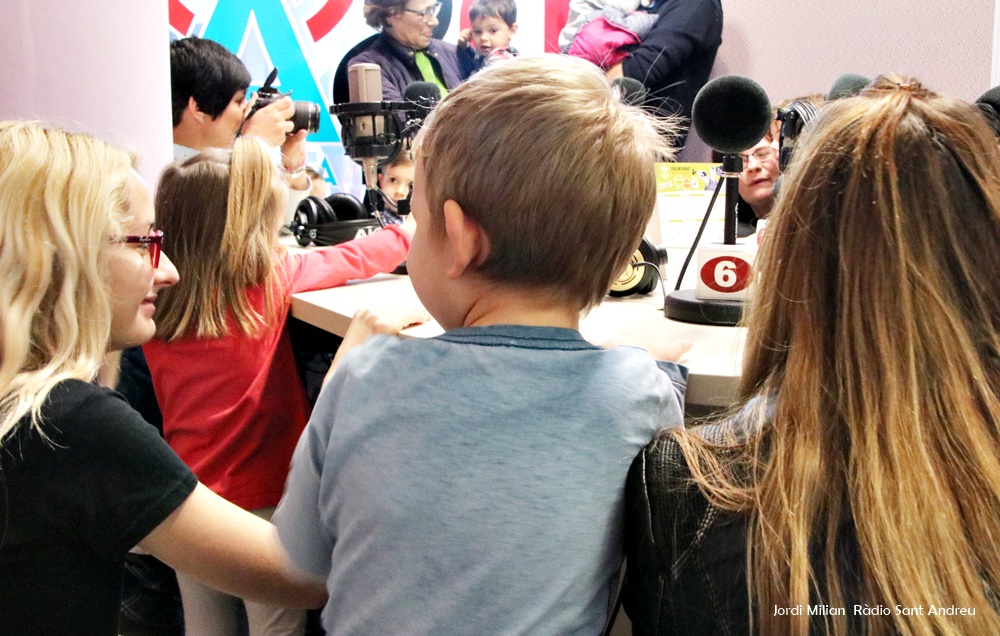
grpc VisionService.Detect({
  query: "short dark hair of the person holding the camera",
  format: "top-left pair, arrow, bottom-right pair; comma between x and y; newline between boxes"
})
170,37 -> 250,127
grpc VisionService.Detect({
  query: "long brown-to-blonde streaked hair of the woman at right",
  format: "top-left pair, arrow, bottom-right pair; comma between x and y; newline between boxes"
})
676,77 -> 1000,634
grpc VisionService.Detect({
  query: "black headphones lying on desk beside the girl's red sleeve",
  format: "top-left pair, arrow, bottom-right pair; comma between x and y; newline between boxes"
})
288,192 -> 382,247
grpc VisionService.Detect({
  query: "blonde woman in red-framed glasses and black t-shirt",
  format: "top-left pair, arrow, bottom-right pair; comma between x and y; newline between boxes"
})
0,121 -> 326,636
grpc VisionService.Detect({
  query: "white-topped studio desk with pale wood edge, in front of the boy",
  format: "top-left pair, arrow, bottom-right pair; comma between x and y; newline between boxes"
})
292,274 -> 746,417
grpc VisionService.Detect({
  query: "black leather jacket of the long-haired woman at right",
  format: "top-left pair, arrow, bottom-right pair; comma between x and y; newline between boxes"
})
622,428 -> 749,636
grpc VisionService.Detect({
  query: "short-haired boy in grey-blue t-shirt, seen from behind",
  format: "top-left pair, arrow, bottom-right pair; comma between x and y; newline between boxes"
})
274,55 -> 686,636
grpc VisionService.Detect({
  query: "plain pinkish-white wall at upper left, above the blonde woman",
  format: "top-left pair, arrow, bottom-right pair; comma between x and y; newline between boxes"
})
0,0 -> 172,186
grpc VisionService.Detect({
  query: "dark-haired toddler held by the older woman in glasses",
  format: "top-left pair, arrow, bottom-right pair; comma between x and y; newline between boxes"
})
458,0 -> 517,77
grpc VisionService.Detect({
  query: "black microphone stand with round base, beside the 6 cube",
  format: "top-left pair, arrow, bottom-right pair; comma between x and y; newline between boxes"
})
663,154 -> 745,327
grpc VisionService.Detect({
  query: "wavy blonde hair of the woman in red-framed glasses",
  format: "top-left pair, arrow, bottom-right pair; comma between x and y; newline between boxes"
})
0,121 -> 132,446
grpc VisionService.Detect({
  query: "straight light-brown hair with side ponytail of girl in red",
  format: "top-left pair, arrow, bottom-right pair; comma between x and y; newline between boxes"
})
154,137 -> 284,341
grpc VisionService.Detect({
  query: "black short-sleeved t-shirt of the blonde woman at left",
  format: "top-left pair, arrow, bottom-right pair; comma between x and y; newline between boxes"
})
0,380 -> 198,636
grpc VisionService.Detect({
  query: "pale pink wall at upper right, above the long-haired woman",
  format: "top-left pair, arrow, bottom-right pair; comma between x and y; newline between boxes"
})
682,0 -> 994,160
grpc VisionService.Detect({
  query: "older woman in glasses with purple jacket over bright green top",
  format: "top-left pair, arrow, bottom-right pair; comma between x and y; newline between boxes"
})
348,0 -> 465,101
